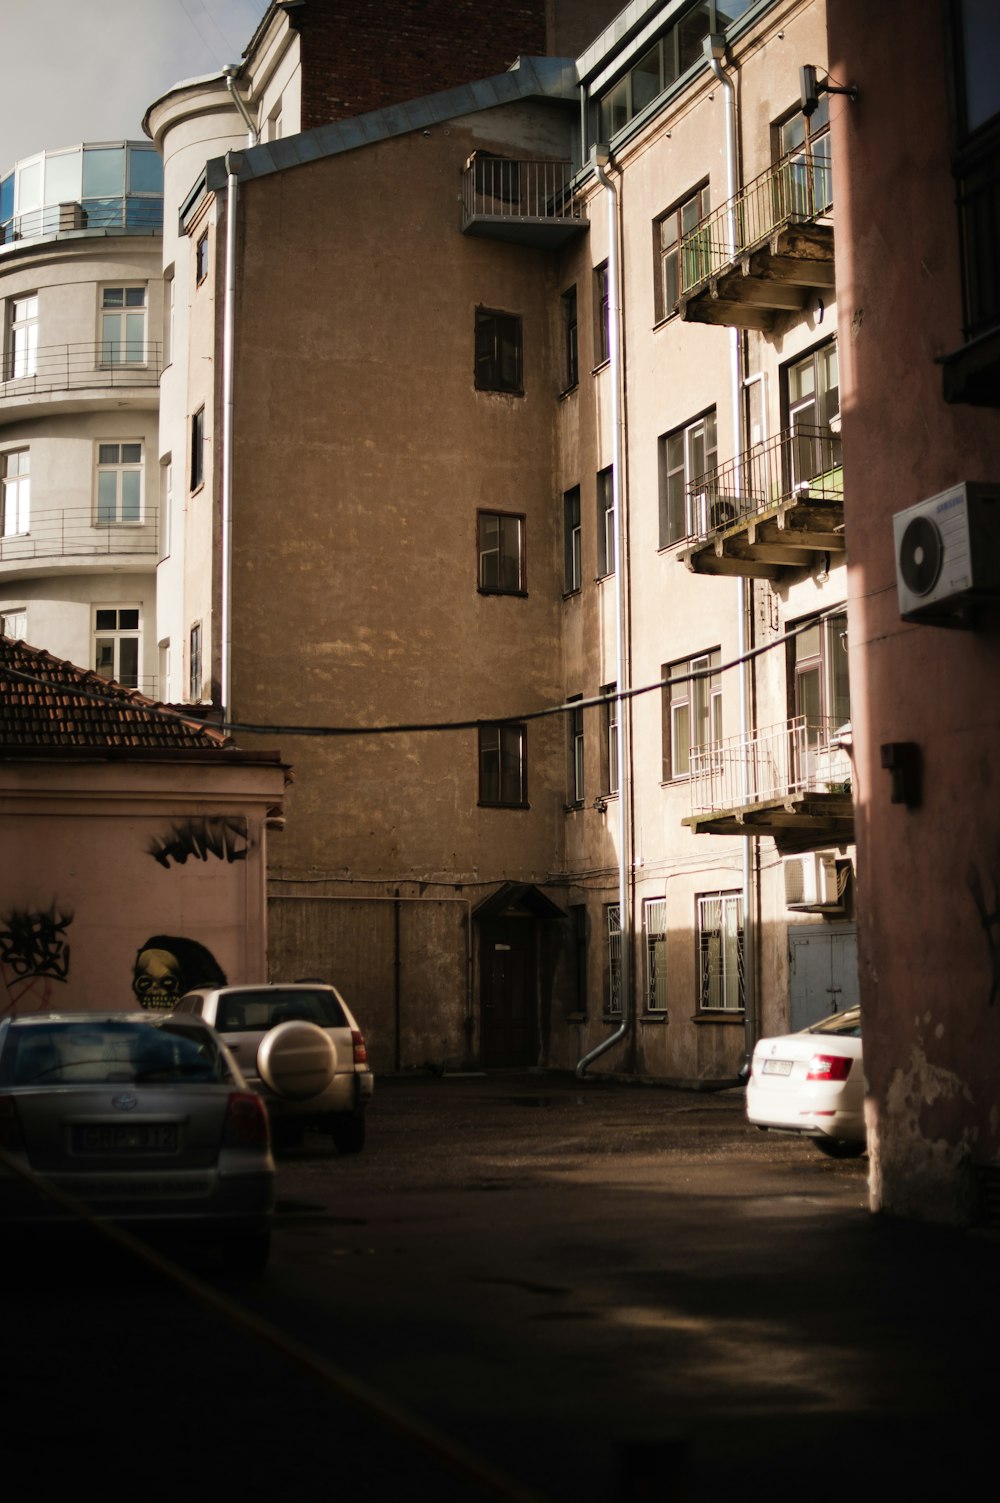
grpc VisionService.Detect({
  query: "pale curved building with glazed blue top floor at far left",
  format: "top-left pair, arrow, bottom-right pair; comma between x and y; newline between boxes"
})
0,141 -> 170,694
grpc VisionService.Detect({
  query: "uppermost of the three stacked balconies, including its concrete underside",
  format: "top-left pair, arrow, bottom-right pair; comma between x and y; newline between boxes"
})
678,150 -> 835,332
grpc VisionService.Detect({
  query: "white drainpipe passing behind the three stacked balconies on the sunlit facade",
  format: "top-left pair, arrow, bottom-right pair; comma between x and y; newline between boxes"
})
705,33 -> 756,1055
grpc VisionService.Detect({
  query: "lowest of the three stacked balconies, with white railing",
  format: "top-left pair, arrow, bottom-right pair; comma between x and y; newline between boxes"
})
683,715 -> 854,852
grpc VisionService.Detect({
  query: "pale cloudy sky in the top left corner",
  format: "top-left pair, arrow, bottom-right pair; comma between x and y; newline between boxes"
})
0,0 -> 268,174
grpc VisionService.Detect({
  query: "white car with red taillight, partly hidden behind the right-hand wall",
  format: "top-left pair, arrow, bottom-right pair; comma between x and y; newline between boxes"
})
746,1007 -> 868,1159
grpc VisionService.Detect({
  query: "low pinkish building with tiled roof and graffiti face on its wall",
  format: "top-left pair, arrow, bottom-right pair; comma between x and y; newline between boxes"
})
0,637 -> 287,1016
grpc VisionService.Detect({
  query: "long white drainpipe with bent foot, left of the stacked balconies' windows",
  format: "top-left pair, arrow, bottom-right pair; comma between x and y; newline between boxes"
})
576,146 -> 632,1078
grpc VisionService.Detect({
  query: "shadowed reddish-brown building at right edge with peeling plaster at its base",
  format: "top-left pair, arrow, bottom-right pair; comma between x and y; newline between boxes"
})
829,0 -> 1000,1220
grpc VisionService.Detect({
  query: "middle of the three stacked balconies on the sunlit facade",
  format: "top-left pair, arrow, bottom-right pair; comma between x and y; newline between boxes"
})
678,424 -> 845,582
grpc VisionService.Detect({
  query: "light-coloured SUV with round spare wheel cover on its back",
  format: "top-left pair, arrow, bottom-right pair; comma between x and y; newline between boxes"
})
174,981 -> 374,1153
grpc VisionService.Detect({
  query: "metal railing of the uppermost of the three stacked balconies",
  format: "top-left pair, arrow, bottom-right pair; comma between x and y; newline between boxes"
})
680,150 -> 833,298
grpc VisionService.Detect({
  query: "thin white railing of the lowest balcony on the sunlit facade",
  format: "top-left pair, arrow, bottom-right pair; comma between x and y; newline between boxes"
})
690,715 -> 851,815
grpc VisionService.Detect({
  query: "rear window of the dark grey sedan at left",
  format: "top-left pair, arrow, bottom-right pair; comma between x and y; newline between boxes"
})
0,1019 -> 229,1085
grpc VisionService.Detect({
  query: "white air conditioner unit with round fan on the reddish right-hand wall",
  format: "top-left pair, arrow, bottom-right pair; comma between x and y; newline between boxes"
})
892,481 -> 1000,625
